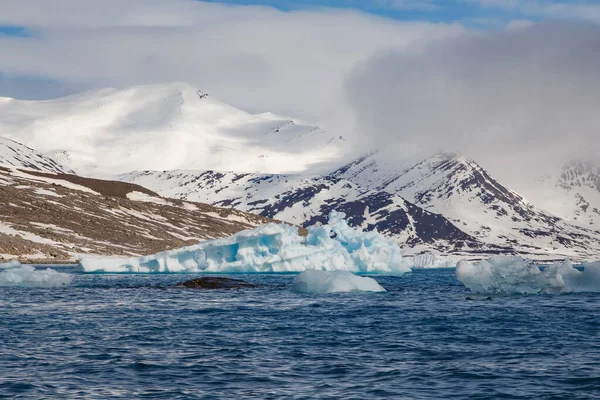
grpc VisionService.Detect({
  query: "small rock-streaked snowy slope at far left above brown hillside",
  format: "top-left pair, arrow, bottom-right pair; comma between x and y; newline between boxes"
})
0,137 -> 72,173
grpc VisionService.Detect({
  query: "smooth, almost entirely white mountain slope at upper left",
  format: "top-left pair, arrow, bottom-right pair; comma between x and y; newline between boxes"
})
0,83 -> 344,176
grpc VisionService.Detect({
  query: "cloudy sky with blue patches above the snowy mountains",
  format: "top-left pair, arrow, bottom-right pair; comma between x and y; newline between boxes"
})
0,0 -> 600,188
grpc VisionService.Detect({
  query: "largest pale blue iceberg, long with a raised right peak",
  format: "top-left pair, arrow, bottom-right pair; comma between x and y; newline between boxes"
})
80,212 -> 411,274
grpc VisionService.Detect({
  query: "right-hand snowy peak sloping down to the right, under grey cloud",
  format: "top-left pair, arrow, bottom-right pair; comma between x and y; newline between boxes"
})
333,153 -> 600,257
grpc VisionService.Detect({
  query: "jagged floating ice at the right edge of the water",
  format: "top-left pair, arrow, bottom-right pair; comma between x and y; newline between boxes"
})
456,256 -> 600,294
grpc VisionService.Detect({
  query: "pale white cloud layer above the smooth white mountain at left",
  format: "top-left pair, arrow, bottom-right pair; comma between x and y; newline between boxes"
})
0,0 -> 462,122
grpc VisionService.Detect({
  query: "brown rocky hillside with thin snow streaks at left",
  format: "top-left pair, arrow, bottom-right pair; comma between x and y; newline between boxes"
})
0,167 -> 269,263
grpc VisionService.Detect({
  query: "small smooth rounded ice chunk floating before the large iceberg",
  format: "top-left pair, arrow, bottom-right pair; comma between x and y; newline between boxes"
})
292,271 -> 386,294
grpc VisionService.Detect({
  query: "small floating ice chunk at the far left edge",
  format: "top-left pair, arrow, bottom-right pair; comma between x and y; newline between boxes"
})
0,265 -> 73,288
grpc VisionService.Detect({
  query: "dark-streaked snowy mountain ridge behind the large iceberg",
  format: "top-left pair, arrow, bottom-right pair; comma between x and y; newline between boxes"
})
121,152 -> 600,259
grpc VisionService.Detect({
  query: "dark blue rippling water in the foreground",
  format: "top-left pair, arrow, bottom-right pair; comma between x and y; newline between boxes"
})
0,270 -> 600,399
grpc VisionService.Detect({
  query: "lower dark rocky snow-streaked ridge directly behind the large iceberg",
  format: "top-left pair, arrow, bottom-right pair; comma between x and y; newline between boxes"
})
120,171 -> 481,252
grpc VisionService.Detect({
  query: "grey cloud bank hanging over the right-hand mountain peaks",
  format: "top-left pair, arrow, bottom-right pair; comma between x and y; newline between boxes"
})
347,23 -> 600,186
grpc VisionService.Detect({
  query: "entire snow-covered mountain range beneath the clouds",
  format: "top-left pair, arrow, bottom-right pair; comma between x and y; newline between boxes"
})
0,83 -> 600,259
